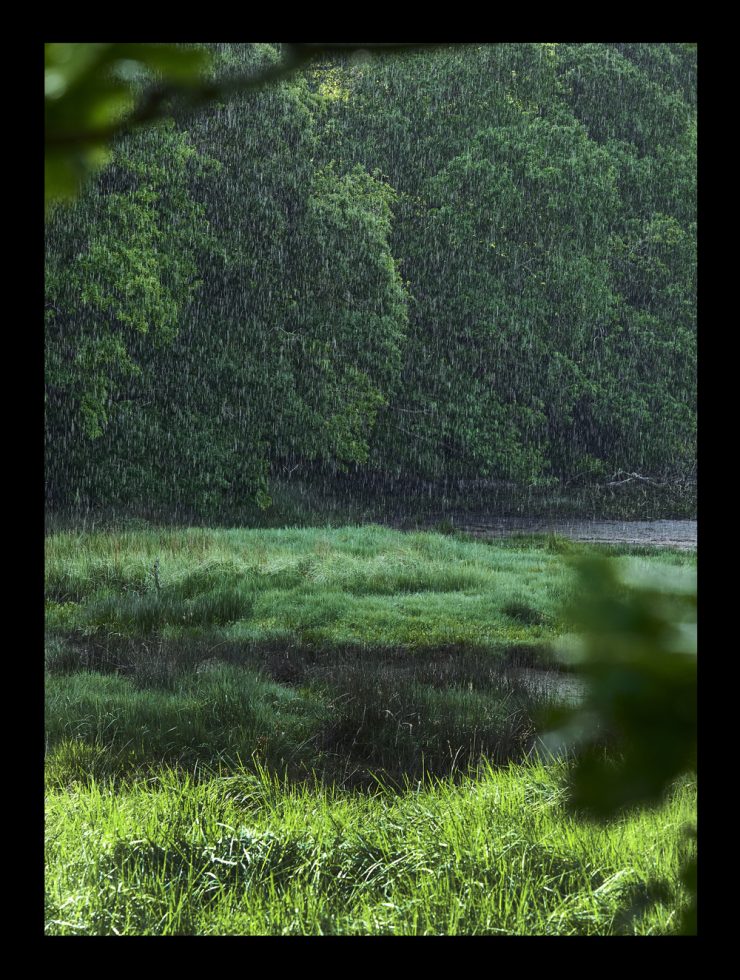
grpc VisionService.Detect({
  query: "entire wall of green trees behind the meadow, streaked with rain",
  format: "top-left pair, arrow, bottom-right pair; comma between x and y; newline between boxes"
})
46,44 -> 696,512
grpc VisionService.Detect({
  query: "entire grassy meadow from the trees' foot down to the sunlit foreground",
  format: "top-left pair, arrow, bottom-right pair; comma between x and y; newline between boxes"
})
45,526 -> 695,935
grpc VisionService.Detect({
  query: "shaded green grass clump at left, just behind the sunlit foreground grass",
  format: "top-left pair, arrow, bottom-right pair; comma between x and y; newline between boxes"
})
46,664 -> 326,784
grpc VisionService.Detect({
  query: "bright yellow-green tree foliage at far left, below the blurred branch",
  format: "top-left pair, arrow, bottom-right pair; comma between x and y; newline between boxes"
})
45,127 -> 214,438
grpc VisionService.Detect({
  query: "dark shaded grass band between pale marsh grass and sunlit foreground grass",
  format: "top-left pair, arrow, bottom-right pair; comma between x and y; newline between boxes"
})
46,660 -> 548,787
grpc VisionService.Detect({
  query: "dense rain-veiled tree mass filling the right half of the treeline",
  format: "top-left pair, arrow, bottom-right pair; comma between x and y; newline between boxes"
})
328,44 -> 696,481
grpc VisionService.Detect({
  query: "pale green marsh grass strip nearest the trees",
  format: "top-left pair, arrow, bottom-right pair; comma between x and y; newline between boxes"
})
46,526 -> 694,649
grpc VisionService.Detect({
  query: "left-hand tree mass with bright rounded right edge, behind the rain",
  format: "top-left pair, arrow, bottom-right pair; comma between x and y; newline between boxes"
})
47,45 -> 406,512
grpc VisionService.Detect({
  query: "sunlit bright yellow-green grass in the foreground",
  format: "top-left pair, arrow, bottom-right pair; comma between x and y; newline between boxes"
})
46,765 -> 695,935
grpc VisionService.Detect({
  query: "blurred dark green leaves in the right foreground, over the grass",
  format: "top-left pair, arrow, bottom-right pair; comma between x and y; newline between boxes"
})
549,559 -> 697,932
